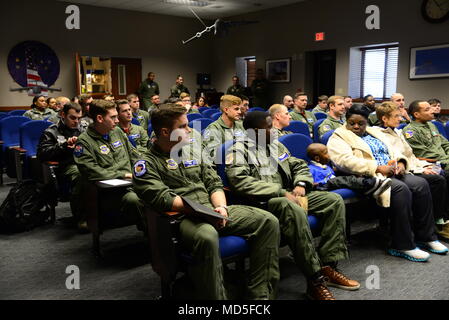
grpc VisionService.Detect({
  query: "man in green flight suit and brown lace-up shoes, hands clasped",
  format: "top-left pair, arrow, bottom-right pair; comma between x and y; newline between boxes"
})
226,111 -> 360,300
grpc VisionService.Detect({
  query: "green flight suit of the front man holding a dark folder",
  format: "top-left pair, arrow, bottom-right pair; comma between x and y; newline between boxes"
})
133,145 -> 280,299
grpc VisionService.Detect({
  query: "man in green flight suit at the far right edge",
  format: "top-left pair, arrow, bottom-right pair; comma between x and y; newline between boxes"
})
402,100 -> 449,239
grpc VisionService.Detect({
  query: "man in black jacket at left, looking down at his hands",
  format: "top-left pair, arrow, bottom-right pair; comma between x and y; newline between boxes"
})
37,102 -> 87,229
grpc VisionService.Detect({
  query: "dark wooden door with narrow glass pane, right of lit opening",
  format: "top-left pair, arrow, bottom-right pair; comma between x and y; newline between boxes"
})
111,58 -> 142,100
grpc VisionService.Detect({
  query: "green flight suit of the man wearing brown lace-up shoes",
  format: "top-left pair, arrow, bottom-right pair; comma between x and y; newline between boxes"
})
226,140 -> 348,277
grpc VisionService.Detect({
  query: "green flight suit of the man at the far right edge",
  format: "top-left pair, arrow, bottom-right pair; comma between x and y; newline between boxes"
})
402,121 -> 449,174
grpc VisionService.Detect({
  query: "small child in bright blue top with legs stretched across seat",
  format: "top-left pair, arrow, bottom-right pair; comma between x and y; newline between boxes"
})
307,143 -> 391,199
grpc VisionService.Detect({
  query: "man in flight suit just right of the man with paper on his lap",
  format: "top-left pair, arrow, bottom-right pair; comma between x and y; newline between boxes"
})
116,99 -> 149,153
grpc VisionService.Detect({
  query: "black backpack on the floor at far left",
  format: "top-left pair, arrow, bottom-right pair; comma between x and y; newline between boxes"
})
0,180 -> 50,233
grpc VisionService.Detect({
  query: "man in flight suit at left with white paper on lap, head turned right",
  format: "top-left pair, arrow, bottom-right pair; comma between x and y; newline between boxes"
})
73,100 -> 144,231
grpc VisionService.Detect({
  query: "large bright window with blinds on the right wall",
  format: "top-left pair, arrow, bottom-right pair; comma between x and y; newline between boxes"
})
349,44 -> 399,99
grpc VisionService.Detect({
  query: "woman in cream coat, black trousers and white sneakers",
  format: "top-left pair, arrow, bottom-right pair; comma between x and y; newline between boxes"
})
327,105 -> 448,262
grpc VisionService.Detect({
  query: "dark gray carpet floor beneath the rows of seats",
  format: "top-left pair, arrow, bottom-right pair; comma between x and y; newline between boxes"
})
0,178 -> 449,300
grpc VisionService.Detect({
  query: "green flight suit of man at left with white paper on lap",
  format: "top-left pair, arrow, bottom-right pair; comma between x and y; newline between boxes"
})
73,125 -> 144,225
